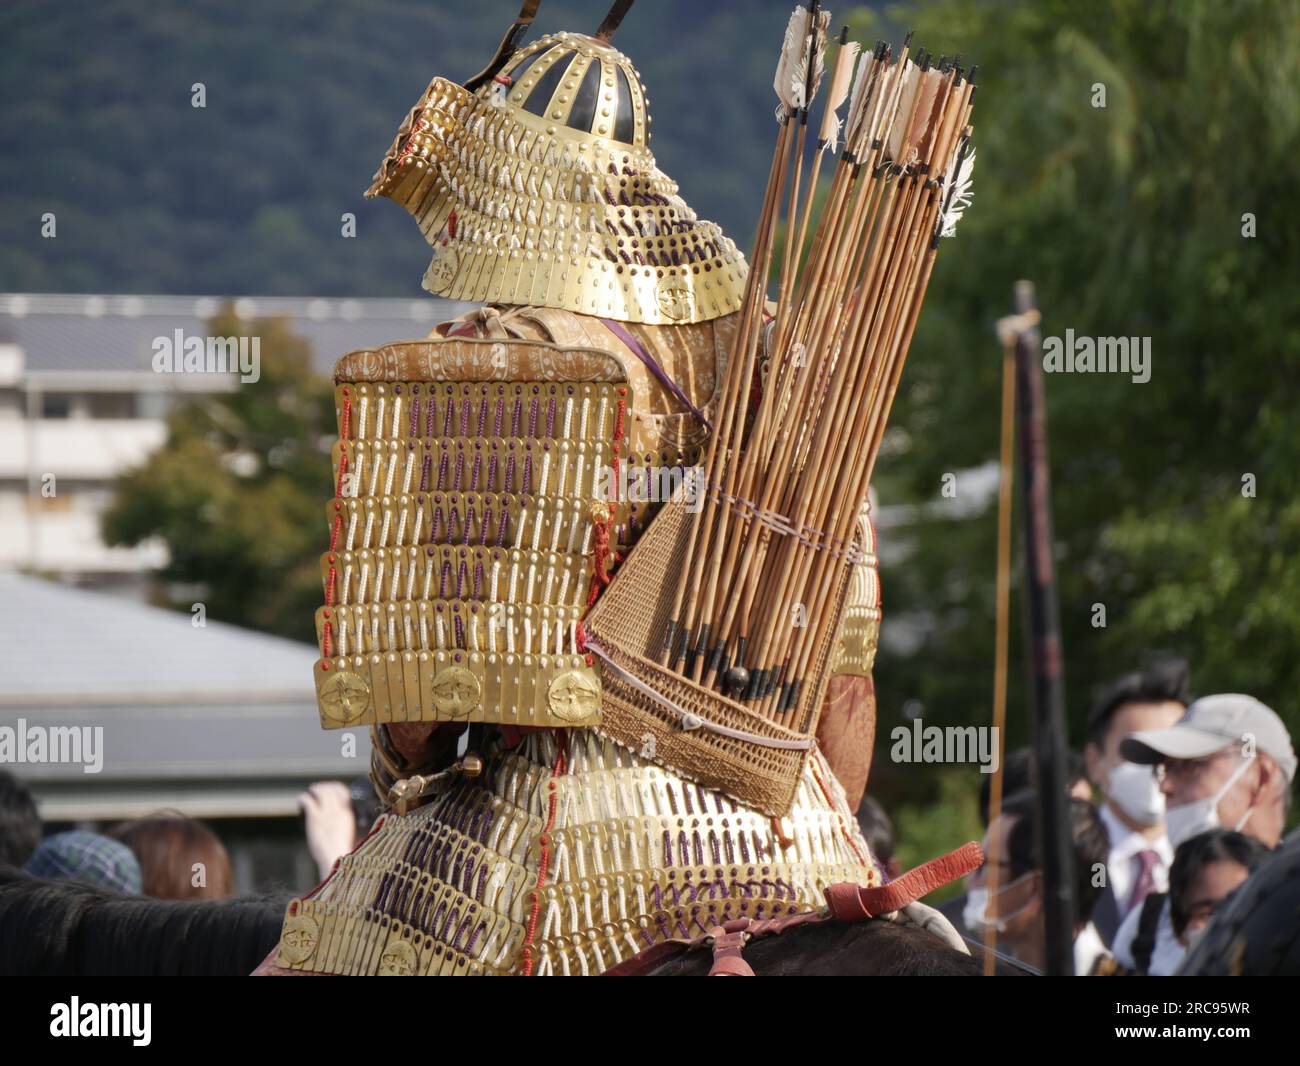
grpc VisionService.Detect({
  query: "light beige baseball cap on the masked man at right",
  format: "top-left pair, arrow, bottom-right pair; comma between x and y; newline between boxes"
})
1119,693 -> 1296,781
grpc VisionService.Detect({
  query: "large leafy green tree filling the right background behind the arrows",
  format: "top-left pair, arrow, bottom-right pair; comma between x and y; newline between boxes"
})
854,0 -> 1300,806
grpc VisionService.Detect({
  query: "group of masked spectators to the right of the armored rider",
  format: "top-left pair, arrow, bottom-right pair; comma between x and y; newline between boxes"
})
859,662 -> 1296,976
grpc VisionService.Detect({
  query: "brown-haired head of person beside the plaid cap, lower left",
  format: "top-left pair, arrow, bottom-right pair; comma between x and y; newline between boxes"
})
109,811 -> 235,900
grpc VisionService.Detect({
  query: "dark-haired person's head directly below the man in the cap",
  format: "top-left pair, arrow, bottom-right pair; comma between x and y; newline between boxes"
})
1169,829 -> 1271,948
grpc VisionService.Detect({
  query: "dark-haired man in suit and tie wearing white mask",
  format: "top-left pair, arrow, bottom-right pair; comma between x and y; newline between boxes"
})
1083,662 -> 1187,944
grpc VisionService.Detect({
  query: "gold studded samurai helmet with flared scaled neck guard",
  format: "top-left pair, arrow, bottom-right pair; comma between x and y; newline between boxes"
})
365,19 -> 746,325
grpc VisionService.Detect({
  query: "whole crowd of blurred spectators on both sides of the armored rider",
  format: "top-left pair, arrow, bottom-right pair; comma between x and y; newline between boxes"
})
0,663 -> 1300,976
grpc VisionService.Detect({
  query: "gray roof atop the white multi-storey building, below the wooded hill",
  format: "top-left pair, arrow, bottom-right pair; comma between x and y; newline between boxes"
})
0,293 -> 472,373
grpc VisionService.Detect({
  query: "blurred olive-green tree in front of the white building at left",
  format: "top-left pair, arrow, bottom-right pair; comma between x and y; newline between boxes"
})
103,308 -> 335,641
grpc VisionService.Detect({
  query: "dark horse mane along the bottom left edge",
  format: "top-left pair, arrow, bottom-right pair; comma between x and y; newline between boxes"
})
0,865 -> 291,978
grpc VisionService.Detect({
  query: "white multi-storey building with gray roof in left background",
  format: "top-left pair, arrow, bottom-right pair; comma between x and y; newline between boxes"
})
0,294 -> 465,593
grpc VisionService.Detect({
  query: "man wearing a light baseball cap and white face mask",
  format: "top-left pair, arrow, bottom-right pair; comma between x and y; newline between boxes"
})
1113,693 -> 1296,976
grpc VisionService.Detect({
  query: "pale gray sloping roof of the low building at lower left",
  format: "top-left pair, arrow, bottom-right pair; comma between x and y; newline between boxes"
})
0,573 -> 371,818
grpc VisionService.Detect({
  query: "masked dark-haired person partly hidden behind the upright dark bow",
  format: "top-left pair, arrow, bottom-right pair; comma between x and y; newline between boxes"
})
963,792 -> 1108,974
